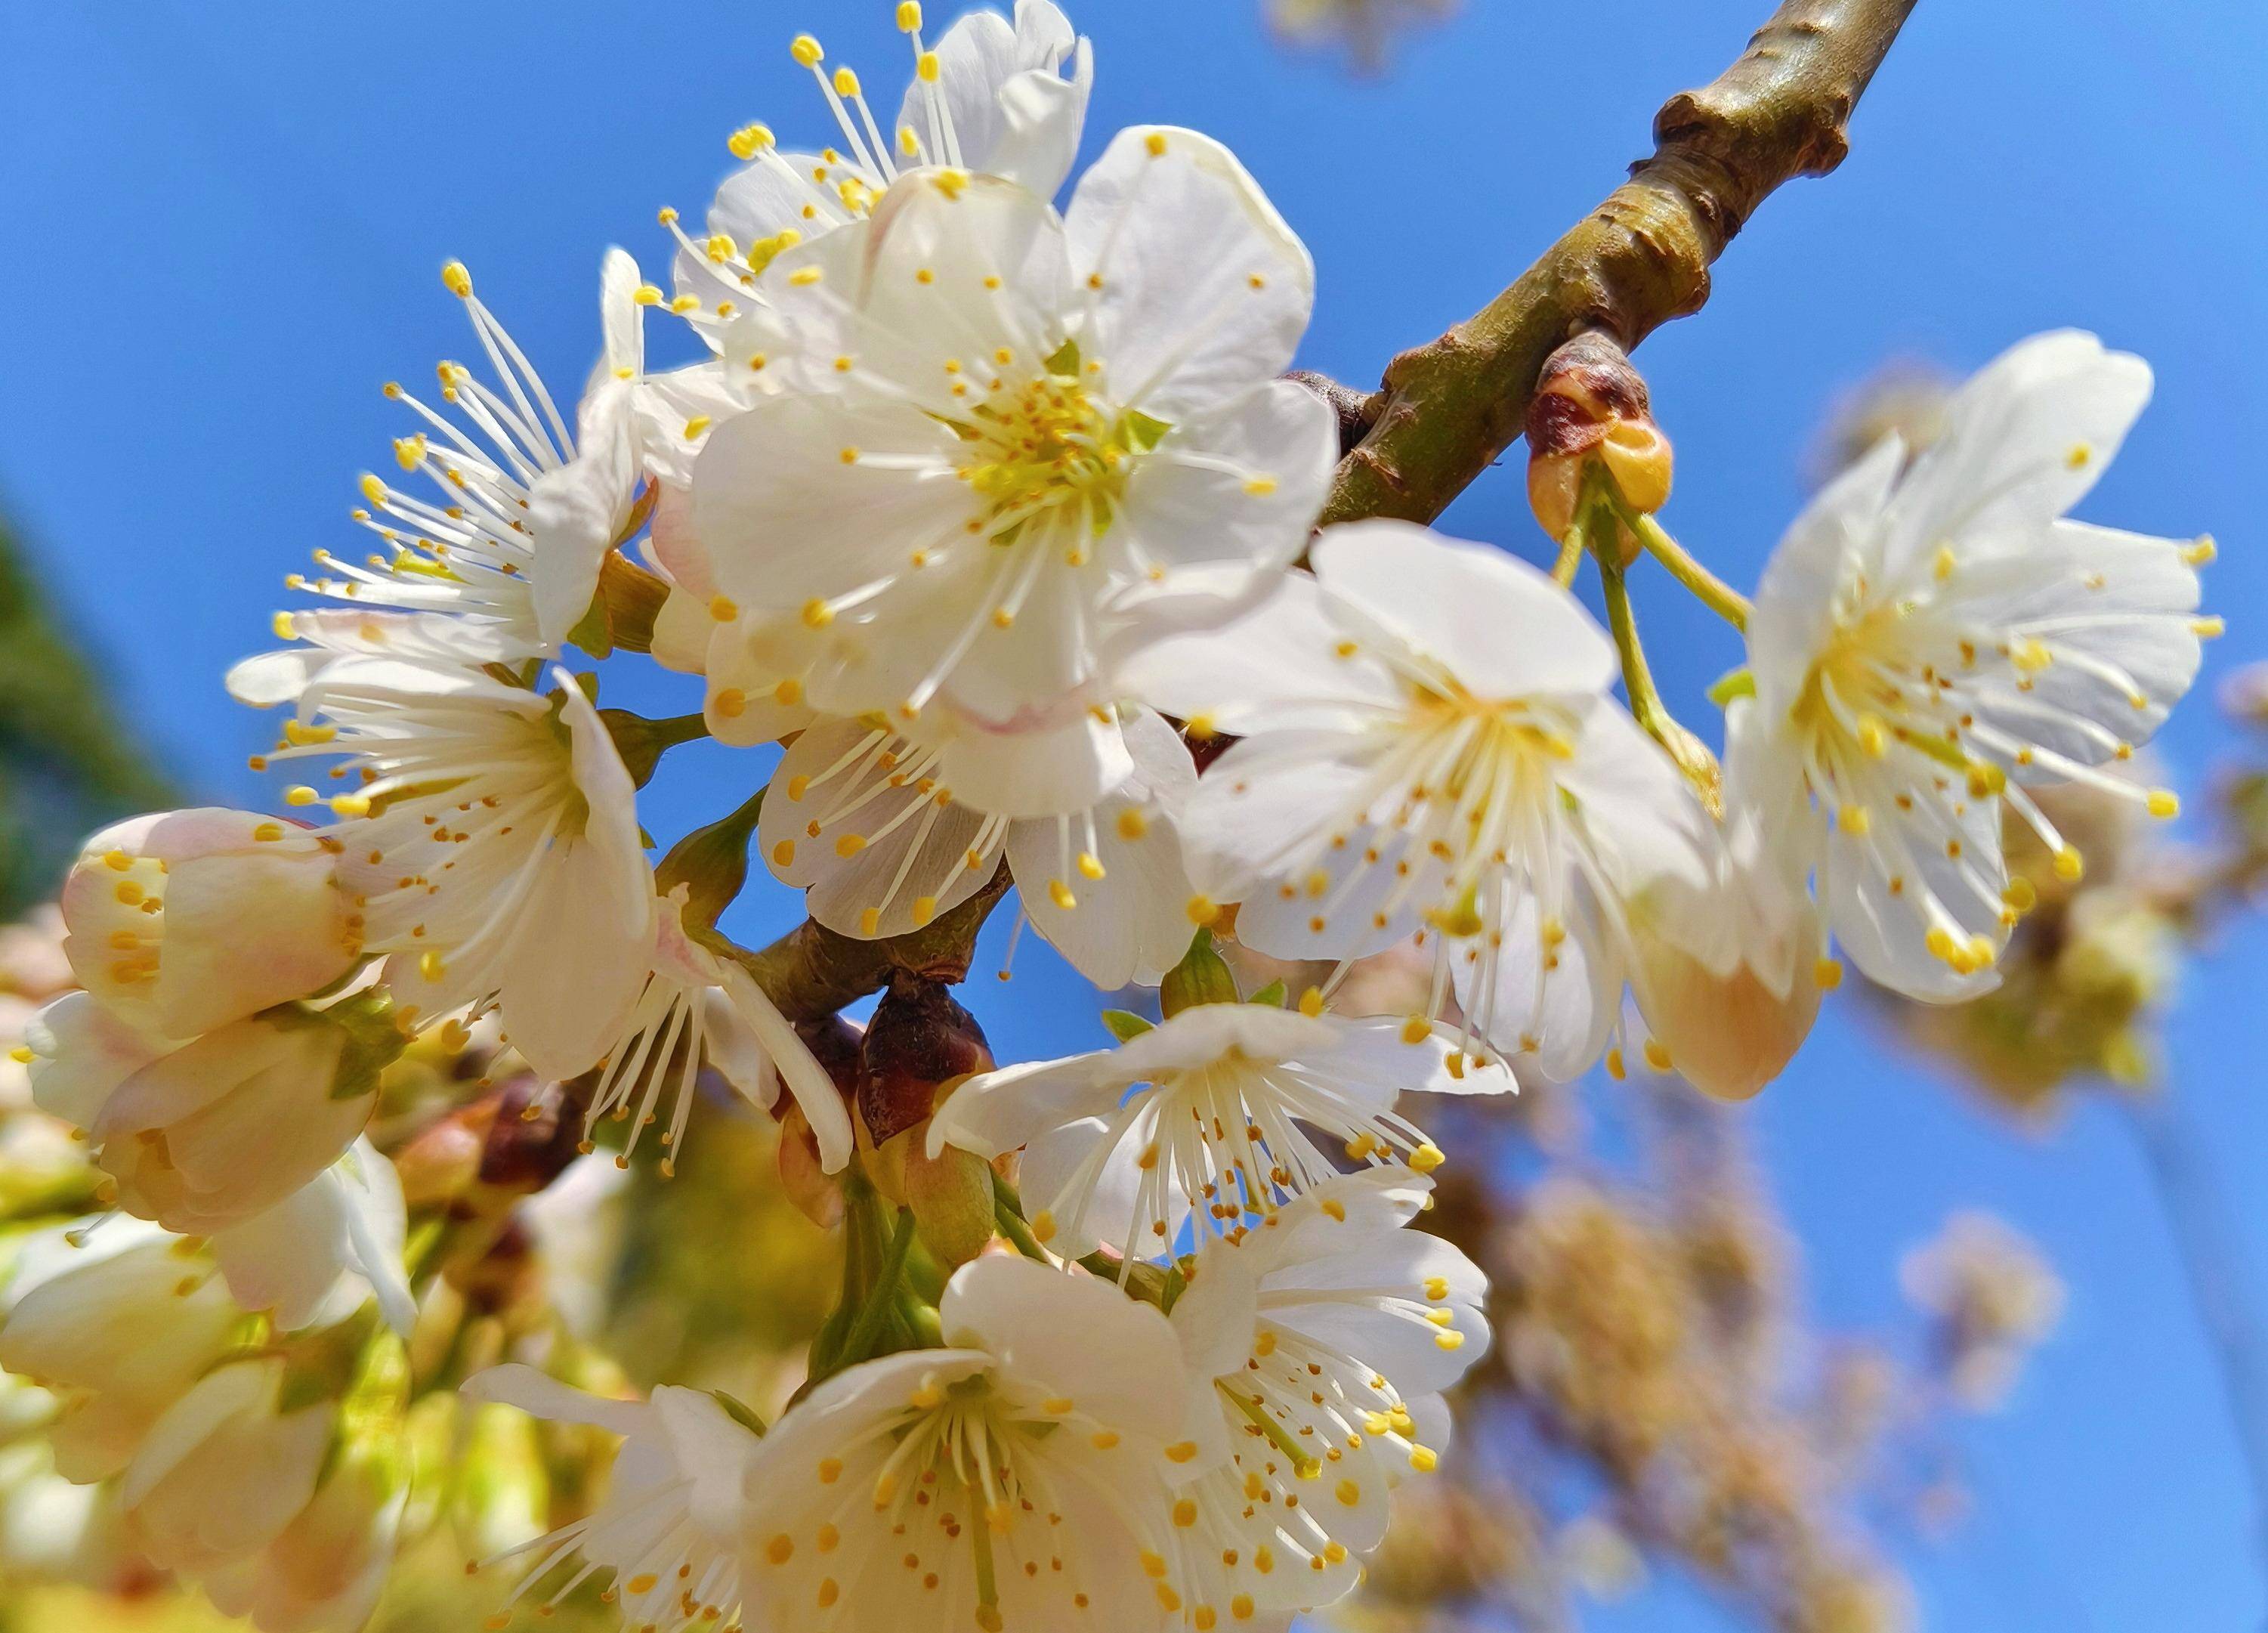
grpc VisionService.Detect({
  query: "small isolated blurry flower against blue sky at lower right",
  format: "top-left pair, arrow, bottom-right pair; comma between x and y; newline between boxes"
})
1899,1214 -> 2064,1411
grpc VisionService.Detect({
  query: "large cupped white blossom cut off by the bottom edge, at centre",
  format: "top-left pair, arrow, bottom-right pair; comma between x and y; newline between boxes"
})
742,1257 -> 1200,1633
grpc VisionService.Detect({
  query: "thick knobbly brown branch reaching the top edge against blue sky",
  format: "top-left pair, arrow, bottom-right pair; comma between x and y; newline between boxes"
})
1322,0 -> 1914,521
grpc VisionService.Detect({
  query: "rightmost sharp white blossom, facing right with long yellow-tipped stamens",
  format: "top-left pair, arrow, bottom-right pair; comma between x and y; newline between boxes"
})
1726,331 -> 2218,1001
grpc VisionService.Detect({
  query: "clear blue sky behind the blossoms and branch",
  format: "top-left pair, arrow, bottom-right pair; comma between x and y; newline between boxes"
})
0,0 -> 2268,1633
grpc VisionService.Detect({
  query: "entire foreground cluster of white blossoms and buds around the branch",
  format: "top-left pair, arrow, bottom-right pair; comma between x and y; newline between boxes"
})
0,0 -> 2202,1633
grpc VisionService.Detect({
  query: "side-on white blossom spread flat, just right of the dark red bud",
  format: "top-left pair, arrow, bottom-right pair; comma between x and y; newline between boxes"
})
930,1003 -> 1515,1257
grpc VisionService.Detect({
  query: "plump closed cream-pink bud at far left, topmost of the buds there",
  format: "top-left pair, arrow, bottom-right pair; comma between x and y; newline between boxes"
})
61,809 -> 360,1039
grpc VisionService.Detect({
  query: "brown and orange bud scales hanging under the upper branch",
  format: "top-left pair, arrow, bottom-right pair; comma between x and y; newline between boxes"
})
1528,329 -> 1673,549
